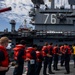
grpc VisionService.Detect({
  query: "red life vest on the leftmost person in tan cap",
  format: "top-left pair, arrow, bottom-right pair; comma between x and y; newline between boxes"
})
0,46 -> 9,67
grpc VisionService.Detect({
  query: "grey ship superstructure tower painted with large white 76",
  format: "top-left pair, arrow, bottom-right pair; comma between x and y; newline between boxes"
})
30,0 -> 75,45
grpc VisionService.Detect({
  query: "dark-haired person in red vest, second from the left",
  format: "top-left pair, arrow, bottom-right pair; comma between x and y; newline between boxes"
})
13,40 -> 26,75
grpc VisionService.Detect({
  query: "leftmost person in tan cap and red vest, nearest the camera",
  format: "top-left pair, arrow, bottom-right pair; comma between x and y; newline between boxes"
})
0,37 -> 11,75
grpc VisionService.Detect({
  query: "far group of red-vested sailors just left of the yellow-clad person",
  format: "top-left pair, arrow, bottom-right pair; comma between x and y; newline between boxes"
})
42,43 -> 71,75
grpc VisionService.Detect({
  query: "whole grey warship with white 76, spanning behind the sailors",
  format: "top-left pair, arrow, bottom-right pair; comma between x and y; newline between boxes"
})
0,0 -> 75,46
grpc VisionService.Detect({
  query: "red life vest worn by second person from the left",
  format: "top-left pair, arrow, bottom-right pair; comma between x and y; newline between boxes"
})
13,44 -> 26,60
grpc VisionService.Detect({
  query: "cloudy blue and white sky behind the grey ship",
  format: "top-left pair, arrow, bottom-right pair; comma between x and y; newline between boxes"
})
0,0 -> 70,31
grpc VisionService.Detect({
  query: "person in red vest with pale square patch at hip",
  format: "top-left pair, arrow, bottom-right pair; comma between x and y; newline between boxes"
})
26,44 -> 37,75
